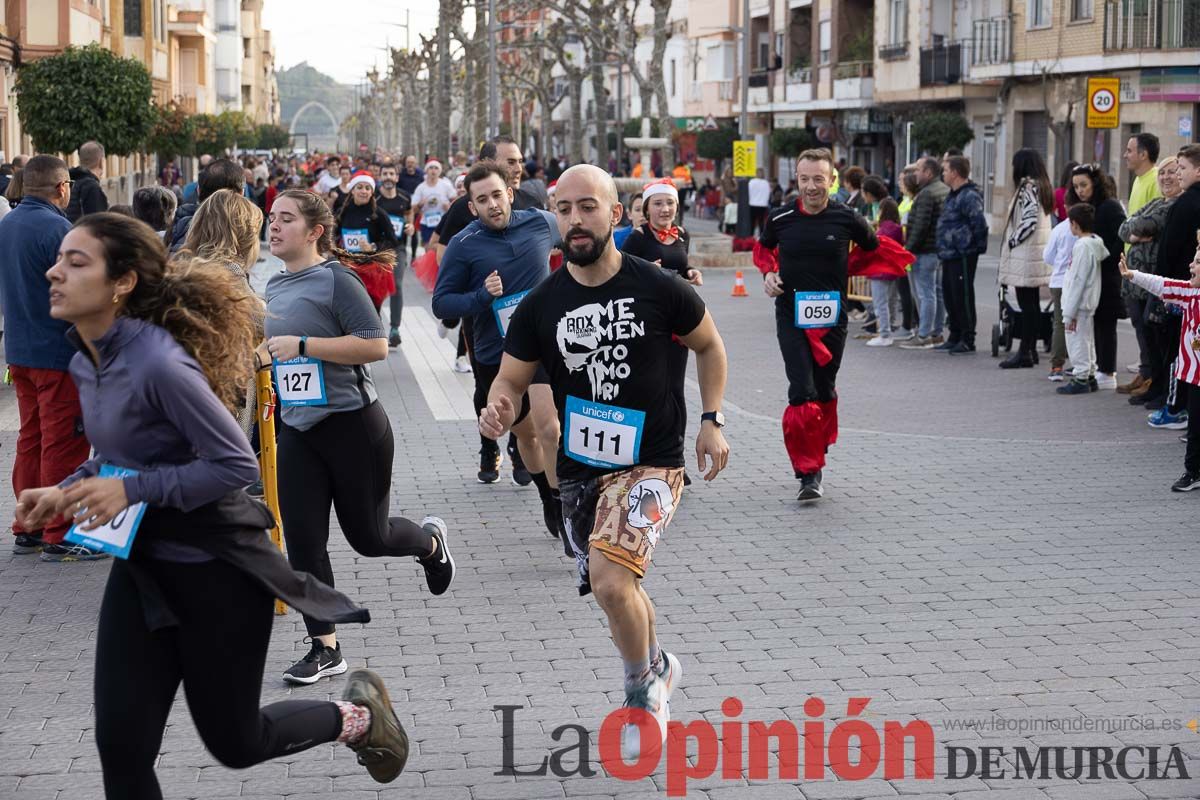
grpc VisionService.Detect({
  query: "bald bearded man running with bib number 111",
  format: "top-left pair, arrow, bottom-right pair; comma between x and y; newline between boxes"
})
479,164 -> 728,760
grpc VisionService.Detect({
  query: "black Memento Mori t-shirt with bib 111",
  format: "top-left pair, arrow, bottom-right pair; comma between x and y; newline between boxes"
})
504,254 -> 704,481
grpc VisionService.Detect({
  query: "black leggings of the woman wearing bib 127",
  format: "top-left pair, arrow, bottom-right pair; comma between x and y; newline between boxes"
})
278,403 -> 433,636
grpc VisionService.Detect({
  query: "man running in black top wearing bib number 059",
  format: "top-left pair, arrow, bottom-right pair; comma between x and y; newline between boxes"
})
754,149 -> 880,503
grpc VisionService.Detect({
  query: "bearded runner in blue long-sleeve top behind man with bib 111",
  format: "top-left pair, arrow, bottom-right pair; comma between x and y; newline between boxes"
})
433,162 -> 562,536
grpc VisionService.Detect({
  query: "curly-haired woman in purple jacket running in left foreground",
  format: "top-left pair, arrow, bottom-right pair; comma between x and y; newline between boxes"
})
17,213 -> 408,800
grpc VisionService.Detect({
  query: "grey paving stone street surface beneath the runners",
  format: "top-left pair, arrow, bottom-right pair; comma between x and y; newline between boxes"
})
0,255 -> 1200,800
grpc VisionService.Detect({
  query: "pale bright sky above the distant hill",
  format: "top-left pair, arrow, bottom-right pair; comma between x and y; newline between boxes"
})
263,0 -> 438,83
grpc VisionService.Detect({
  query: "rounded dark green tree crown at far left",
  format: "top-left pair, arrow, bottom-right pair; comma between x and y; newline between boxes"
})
16,44 -> 156,156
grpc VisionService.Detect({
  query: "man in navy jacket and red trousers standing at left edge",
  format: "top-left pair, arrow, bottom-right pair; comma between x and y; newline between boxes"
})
0,156 -> 90,561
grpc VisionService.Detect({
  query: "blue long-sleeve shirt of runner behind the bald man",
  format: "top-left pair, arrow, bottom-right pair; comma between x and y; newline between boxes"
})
433,209 -> 559,365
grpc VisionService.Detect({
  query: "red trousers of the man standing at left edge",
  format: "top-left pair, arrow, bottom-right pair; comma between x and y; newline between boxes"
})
8,365 -> 90,543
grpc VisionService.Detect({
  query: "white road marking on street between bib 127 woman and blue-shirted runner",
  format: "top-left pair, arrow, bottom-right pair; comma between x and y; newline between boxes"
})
400,306 -> 475,422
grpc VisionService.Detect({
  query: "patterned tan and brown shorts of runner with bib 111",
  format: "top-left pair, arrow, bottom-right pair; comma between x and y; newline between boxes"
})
559,467 -> 684,595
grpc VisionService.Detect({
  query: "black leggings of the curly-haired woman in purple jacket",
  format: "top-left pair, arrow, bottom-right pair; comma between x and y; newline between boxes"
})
95,559 -> 342,800
